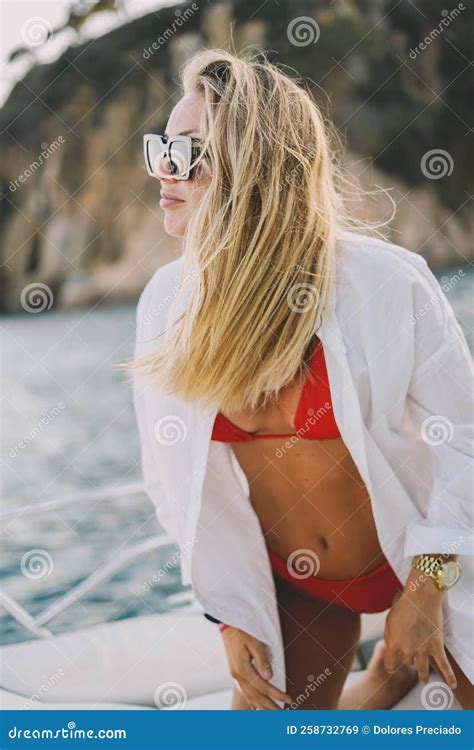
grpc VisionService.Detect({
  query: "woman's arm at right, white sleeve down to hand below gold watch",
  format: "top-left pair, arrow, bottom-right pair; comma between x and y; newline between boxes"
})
384,256 -> 474,689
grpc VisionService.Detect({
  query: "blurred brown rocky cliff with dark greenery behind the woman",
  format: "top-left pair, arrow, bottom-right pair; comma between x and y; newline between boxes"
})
0,0 -> 473,311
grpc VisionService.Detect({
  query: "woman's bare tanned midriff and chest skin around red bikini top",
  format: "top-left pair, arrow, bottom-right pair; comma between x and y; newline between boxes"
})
220,376 -> 387,579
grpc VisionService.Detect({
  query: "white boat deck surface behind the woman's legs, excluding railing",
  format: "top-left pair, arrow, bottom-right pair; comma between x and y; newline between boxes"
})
0,606 -> 460,710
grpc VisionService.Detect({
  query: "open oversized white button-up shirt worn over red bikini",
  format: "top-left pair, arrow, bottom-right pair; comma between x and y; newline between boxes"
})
134,232 -> 474,690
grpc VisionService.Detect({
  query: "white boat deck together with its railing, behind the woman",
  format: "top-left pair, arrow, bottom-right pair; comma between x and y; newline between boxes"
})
0,483 -> 460,710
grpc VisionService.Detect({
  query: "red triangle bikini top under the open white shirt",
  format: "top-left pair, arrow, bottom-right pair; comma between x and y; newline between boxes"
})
211,336 -> 340,443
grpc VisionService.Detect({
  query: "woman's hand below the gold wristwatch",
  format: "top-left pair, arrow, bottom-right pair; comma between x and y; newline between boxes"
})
384,571 -> 457,690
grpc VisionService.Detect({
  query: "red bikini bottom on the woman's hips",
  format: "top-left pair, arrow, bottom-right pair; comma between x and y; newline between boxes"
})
268,550 -> 403,614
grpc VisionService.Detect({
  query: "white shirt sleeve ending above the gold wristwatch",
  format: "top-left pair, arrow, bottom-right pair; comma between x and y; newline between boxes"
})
404,256 -> 474,556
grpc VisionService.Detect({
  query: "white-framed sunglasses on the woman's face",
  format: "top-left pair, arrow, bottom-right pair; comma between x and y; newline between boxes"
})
143,133 -> 202,180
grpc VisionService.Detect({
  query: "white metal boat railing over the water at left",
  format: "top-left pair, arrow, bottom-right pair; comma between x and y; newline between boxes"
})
0,482 -> 192,638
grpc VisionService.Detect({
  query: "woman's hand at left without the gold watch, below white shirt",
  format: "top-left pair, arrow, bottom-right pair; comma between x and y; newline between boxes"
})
222,626 -> 292,711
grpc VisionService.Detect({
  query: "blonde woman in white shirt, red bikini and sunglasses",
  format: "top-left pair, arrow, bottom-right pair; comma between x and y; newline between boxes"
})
128,50 -> 474,710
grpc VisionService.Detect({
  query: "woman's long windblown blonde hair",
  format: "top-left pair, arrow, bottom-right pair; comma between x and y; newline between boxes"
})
121,49 -> 388,413
